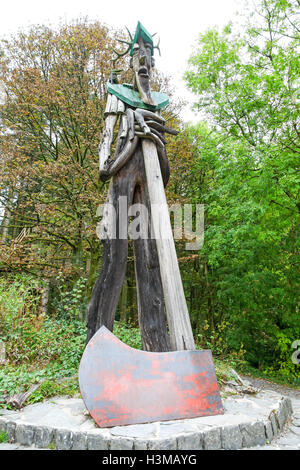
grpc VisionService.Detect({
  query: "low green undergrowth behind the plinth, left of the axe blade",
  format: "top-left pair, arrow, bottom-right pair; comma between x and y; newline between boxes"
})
0,275 -> 146,406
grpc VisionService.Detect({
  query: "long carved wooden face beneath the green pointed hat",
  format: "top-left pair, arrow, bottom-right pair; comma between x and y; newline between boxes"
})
130,38 -> 155,105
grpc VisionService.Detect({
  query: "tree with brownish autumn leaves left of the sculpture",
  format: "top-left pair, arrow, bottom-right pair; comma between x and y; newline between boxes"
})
0,20 -> 192,324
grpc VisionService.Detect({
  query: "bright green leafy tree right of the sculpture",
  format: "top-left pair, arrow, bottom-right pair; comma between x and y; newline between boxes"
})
185,0 -> 300,373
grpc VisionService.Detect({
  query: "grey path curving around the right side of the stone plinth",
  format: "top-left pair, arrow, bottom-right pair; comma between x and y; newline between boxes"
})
243,377 -> 300,450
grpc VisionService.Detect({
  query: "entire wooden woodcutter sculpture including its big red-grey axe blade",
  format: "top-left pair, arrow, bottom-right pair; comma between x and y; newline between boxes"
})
78,23 -> 224,426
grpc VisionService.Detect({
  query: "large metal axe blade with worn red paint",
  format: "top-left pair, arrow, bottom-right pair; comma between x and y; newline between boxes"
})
79,326 -> 224,427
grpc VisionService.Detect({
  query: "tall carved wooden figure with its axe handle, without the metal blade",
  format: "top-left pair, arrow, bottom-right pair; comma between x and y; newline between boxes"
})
87,22 -> 195,351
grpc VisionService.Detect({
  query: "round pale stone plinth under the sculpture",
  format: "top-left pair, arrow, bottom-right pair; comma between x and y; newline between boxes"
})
0,390 -> 299,450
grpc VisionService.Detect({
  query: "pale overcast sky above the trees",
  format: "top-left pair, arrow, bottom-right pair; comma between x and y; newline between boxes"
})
0,0 -> 244,122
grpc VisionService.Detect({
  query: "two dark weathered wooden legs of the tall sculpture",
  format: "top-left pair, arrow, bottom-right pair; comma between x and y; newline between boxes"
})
87,145 -> 170,352
